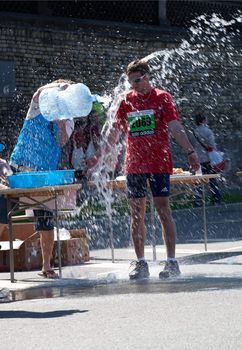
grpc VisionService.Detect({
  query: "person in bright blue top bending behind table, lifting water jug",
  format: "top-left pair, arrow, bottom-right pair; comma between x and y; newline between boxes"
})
0,79 -> 74,278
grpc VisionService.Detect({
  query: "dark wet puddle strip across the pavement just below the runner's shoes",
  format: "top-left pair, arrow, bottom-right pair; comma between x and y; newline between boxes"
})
5,275 -> 242,302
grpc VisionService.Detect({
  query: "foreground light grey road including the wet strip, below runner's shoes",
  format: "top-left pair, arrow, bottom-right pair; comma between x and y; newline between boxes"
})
0,264 -> 242,350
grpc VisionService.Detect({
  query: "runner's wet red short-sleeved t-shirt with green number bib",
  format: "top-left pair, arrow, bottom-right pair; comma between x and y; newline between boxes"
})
114,88 -> 179,174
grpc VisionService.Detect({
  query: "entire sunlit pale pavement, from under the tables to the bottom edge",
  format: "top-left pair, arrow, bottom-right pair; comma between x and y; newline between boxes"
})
0,241 -> 242,350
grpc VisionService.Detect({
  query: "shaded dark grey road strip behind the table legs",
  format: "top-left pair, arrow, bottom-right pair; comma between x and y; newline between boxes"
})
63,203 -> 242,249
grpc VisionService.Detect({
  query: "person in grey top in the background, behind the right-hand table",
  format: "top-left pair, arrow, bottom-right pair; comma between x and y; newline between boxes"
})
189,114 -> 222,205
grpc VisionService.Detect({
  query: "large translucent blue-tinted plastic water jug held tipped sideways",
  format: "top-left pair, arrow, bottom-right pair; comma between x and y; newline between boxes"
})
39,83 -> 96,121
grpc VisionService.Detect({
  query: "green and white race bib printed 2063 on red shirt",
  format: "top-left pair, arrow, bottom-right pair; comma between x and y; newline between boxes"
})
128,109 -> 155,136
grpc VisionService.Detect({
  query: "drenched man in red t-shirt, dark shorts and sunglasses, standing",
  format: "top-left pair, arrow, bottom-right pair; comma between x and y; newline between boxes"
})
88,60 -> 199,279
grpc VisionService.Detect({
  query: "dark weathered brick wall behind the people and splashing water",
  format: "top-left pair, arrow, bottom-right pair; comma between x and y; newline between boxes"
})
0,13 -> 242,189
